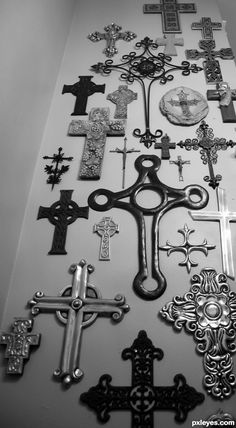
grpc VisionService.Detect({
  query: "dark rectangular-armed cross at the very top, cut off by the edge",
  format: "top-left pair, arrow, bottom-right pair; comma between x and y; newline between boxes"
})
143,0 -> 197,33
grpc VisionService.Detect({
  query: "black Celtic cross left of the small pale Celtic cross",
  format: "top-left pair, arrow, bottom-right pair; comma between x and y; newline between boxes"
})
37,190 -> 89,255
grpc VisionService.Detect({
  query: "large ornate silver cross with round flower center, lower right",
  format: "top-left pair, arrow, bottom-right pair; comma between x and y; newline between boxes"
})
160,268 -> 236,399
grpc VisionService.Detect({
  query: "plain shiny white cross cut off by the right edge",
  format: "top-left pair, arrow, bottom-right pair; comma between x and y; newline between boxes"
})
189,188 -> 236,279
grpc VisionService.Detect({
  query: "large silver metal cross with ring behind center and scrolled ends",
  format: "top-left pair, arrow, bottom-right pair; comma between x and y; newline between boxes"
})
29,260 -> 129,385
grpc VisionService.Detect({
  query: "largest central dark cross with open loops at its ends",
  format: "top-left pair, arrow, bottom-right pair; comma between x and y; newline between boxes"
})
88,155 -> 208,300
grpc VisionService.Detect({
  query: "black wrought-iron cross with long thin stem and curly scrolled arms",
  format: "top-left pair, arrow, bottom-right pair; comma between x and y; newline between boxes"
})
91,37 -> 202,148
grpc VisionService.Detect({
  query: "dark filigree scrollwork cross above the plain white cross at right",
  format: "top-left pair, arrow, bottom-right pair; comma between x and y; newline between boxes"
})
177,120 -> 236,189
